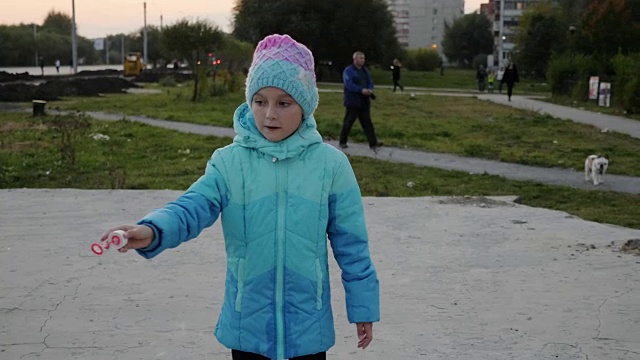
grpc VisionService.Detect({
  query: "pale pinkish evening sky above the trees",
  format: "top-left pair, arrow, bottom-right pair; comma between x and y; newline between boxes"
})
0,0 -> 487,39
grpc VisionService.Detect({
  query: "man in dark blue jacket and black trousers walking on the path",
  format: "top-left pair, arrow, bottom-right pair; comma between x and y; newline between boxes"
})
340,51 -> 383,150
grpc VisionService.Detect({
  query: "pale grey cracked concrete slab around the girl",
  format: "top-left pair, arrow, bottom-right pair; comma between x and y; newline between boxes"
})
0,189 -> 640,360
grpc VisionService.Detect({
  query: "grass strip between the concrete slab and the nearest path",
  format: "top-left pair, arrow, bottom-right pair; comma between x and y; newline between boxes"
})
0,112 -> 640,229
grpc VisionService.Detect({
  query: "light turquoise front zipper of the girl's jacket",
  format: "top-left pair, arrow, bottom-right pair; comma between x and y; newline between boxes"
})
273,157 -> 287,359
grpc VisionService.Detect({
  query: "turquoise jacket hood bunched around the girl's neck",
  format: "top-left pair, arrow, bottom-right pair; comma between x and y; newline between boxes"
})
233,103 -> 322,160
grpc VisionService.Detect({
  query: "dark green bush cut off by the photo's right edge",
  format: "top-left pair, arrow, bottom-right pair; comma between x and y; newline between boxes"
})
611,53 -> 640,113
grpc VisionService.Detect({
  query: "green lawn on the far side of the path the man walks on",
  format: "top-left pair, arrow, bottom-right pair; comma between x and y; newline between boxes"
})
50,85 -> 640,176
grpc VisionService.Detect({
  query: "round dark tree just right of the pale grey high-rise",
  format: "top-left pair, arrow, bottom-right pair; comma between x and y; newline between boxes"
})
442,13 -> 493,67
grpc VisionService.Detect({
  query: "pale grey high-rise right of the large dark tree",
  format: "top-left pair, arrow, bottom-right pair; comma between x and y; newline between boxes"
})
386,0 -> 464,54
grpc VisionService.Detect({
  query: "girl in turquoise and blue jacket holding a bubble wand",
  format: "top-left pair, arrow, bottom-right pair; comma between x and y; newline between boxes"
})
102,35 -> 380,360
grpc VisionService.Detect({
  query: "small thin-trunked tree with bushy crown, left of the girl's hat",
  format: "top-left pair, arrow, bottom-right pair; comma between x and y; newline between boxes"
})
162,19 -> 223,101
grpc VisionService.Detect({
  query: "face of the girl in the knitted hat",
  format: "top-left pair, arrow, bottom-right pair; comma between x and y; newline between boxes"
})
251,87 -> 302,142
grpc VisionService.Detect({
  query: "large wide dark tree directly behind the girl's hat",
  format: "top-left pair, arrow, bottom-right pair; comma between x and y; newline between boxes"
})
233,0 -> 400,70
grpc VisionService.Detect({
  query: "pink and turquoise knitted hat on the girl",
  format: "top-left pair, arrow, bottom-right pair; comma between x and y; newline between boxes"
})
246,34 -> 318,119
